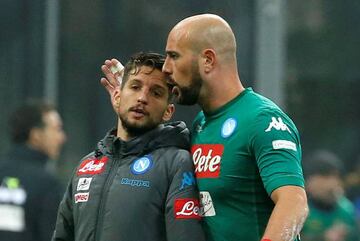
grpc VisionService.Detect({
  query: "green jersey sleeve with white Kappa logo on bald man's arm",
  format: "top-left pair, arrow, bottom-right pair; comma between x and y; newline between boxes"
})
249,108 -> 304,195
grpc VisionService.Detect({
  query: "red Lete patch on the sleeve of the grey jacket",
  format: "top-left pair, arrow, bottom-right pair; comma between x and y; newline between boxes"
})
174,198 -> 201,219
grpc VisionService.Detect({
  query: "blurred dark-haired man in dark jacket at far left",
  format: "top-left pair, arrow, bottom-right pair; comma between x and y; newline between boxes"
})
0,101 -> 66,241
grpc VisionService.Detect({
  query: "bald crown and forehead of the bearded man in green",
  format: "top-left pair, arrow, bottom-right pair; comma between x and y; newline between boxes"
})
170,14 -> 236,60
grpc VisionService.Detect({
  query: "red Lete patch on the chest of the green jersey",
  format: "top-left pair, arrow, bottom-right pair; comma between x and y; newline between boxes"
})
191,144 -> 224,178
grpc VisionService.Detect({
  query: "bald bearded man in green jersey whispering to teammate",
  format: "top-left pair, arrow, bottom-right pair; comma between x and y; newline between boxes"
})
102,14 -> 308,241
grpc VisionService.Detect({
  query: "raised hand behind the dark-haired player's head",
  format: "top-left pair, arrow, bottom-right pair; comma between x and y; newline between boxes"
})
100,59 -> 124,112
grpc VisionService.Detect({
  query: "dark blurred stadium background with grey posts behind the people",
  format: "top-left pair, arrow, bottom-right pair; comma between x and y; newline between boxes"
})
0,0 -> 360,182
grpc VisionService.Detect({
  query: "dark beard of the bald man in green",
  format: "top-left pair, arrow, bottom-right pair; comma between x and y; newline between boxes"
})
177,62 -> 203,105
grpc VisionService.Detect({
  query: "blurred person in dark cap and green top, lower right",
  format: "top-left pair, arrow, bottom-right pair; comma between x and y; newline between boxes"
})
302,150 -> 359,241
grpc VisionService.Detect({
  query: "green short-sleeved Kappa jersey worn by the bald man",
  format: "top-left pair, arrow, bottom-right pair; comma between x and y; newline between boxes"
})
191,88 -> 304,241
